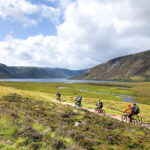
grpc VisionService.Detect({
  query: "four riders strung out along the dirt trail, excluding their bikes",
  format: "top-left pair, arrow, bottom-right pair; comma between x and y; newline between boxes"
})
56,93 -> 140,122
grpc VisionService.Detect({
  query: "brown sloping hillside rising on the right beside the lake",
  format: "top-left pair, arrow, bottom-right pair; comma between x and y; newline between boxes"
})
76,50 -> 150,81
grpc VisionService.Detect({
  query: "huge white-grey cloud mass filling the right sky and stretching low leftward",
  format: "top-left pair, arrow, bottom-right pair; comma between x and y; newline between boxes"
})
0,0 -> 150,69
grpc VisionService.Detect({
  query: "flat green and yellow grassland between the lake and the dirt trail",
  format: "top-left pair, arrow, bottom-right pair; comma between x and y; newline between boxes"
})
0,82 -> 150,123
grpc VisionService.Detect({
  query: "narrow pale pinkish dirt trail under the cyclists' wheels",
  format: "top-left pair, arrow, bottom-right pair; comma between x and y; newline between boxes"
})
40,95 -> 150,129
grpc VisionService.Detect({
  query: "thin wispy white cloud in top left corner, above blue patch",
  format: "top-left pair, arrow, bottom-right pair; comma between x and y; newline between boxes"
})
0,0 -> 60,27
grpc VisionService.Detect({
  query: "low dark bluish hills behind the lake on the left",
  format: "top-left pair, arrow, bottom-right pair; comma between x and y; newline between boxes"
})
0,64 -> 87,79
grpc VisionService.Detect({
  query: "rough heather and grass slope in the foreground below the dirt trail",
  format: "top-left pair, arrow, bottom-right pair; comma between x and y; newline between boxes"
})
0,94 -> 150,150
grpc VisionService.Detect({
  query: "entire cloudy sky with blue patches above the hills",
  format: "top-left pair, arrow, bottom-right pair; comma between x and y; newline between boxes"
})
0,0 -> 150,70
